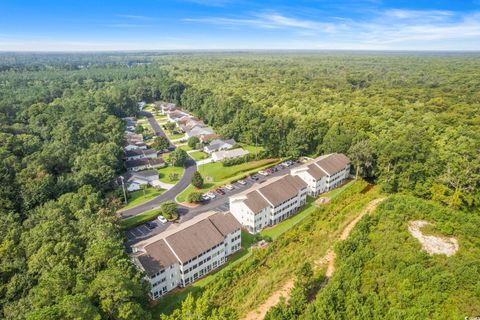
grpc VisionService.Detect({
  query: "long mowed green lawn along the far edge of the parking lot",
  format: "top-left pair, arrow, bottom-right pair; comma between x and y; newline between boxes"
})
177,159 -> 281,202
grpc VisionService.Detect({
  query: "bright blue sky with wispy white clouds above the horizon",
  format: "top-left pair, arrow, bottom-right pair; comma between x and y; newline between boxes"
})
0,0 -> 480,51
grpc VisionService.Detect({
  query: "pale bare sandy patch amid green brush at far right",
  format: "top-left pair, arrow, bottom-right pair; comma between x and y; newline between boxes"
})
408,220 -> 458,257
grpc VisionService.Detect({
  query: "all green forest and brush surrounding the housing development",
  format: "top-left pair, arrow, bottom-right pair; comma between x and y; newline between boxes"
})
0,52 -> 480,319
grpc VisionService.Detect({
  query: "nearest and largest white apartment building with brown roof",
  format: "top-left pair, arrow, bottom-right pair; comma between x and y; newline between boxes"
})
132,211 -> 241,299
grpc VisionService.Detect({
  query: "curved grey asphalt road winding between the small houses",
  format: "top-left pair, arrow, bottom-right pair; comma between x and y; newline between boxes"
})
119,111 -> 197,219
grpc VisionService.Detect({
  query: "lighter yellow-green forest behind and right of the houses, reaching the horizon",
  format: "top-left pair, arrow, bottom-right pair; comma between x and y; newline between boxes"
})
159,54 -> 480,209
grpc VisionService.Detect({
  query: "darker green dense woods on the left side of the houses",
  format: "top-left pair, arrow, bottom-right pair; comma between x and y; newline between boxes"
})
0,56 -> 186,319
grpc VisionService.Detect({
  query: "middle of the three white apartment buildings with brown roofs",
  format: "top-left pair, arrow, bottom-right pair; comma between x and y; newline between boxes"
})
229,175 -> 307,234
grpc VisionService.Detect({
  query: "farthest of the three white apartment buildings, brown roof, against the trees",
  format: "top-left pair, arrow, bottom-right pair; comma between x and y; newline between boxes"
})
290,153 -> 350,197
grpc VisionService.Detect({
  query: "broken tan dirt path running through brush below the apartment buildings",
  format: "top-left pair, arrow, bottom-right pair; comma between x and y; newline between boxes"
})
244,198 -> 385,320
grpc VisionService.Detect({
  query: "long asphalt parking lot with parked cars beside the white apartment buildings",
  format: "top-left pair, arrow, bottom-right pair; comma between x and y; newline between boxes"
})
126,163 -> 300,246
